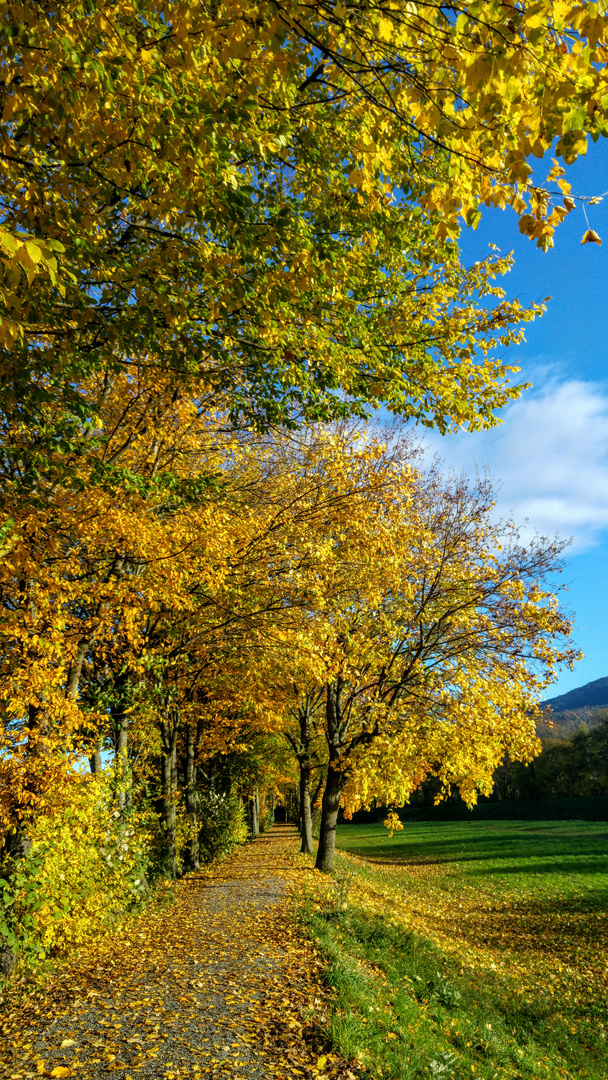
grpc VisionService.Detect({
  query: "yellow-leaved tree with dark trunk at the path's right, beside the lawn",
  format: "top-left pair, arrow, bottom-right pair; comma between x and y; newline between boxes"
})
295,463 -> 577,870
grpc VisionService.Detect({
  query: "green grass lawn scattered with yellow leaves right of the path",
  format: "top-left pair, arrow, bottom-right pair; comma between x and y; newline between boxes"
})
306,821 -> 608,1080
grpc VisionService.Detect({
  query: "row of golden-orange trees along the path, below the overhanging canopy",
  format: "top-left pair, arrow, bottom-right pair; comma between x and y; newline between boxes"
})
0,416 -> 572,967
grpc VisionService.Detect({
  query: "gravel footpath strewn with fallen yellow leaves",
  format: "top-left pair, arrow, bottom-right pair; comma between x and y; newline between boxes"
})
0,825 -> 341,1080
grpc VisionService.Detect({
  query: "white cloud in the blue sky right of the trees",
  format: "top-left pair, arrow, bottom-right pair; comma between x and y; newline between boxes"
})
424,368 -> 608,552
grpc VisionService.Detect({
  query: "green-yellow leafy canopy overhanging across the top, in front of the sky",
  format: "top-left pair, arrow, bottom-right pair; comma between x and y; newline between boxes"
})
0,0 -> 606,473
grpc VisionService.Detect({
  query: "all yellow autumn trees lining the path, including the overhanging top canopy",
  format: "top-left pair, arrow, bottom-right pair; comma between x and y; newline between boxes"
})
0,0 -> 608,967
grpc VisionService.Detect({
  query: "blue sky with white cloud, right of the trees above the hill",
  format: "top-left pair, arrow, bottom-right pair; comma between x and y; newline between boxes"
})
424,140 -> 608,696
